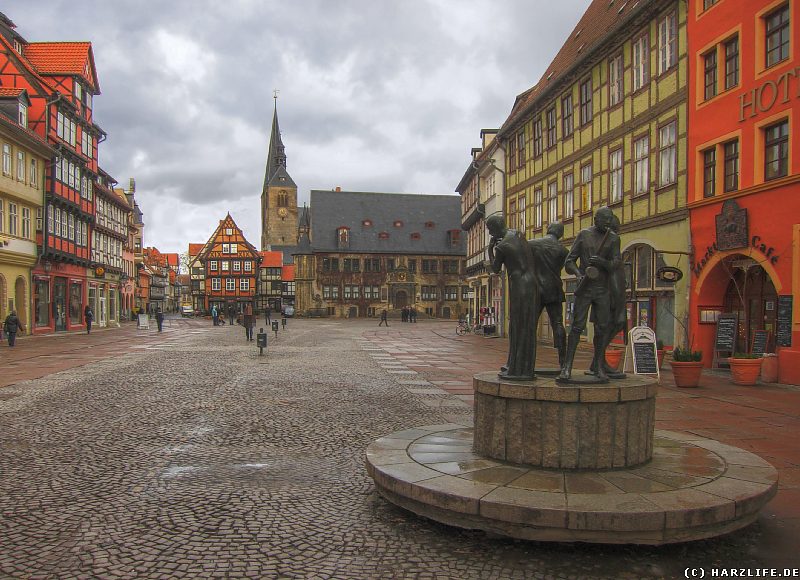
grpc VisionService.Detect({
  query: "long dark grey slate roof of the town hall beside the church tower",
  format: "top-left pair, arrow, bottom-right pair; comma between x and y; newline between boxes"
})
310,190 -> 466,256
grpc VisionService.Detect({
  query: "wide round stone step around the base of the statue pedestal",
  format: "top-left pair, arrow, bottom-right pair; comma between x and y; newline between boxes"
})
366,424 -> 778,545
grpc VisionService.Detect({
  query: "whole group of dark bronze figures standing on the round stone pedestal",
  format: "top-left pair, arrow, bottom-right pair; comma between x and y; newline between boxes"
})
486,207 -> 627,381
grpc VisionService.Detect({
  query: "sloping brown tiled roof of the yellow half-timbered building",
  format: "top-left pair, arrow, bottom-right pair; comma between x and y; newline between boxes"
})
498,0 -> 657,136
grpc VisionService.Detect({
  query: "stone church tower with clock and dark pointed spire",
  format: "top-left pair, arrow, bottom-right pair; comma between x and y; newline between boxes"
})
261,92 -> 297,250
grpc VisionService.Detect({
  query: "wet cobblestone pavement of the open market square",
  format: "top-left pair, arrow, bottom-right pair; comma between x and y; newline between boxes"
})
0,320 -> 797,578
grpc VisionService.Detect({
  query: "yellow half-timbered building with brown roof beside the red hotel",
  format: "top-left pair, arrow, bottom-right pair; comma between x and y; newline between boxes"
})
499,0 -> 689,345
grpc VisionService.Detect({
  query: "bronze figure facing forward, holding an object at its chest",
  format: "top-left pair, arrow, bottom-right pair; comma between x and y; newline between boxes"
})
558,207 -> 621,382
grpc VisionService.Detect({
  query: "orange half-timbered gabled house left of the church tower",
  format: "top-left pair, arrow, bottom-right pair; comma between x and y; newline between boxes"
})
197,214 -> 261,312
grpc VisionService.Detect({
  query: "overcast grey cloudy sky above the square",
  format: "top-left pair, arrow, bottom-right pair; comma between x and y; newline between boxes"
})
15,0 -> 589,252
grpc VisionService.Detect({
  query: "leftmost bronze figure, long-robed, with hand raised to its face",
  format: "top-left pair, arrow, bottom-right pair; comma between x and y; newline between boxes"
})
486,214 -> 541,381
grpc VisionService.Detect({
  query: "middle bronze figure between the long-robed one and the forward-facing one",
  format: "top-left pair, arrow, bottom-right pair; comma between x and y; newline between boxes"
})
528,222 -> 569,367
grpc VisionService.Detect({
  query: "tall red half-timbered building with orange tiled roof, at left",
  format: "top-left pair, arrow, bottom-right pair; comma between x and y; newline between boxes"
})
0,17 -> 105,333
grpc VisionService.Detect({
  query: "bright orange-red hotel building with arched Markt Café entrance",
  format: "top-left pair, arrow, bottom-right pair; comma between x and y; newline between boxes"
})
688,0 -> 800,384
